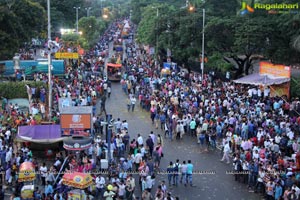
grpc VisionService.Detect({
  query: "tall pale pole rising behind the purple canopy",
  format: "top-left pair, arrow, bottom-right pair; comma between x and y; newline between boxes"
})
47,0 -> 52,121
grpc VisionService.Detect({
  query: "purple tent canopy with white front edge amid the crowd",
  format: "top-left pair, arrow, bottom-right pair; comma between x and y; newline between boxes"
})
17,125 -> 64,144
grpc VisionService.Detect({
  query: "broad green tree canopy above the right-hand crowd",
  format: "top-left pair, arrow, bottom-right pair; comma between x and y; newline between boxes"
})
132,0 -> 300,77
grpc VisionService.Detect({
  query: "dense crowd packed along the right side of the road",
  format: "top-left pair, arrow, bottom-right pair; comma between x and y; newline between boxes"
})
121,28 -> 300,199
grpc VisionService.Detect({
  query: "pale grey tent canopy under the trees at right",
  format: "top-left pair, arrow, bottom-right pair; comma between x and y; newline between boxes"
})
233,73 -> 290,86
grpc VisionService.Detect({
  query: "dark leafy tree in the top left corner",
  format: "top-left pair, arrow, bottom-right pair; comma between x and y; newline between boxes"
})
0,0 -> 45,59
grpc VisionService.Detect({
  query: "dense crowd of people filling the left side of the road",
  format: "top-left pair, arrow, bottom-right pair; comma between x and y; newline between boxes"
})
0,18 -> 184,200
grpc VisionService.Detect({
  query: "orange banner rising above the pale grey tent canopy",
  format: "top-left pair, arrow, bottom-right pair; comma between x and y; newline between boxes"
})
259,62 -> 291,78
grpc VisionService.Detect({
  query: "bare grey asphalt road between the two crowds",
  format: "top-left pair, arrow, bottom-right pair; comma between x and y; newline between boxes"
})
106,83 -> 260,200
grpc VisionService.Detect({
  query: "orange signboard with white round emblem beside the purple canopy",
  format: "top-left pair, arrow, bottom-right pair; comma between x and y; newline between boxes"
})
60,114 -> 92,129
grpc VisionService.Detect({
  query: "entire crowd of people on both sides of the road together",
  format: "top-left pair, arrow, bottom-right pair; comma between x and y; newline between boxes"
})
0,14 -> 300,200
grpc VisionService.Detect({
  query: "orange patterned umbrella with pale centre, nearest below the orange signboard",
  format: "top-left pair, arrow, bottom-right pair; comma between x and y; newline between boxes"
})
62,172 -> 93,189
